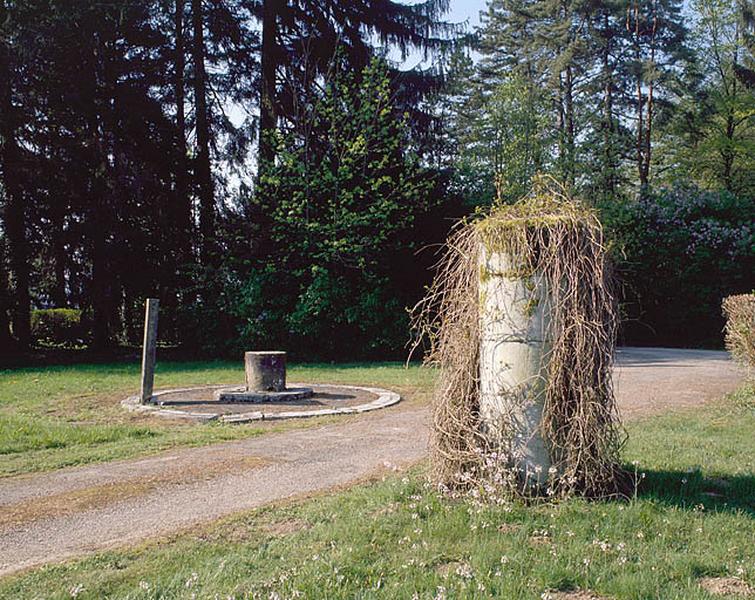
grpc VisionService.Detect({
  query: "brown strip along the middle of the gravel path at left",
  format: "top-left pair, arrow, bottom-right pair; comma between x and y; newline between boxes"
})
0,456 -> 270,528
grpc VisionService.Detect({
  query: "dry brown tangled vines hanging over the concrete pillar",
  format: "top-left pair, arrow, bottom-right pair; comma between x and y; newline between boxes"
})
414,180 -> 628,496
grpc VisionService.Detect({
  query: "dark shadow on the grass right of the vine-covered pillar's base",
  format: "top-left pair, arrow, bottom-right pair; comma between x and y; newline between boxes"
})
637,469 -> 755,518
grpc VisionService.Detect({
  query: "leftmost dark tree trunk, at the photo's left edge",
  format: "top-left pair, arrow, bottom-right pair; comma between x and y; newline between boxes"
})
0,36 -> 31,348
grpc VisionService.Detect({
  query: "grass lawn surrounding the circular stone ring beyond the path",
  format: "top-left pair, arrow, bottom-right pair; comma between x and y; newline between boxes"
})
0,361 -> 432,477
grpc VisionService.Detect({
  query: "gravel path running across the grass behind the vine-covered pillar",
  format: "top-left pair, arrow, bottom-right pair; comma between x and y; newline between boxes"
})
0,348 -> 740,575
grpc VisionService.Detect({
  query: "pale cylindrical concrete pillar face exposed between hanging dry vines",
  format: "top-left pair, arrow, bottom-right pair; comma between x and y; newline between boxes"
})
480,247 -> 551,485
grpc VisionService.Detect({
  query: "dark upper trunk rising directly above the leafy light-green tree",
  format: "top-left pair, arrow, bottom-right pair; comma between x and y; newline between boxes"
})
257,0 -> 280,174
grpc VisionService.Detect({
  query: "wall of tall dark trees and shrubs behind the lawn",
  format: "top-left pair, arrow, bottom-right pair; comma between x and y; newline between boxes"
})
0,0 -> 755,360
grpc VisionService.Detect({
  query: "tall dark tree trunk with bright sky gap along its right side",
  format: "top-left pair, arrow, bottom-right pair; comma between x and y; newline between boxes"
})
191,0 -> 215,265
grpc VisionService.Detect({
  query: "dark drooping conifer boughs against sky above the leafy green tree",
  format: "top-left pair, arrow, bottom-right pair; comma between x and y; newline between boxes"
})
258,0 -> 461,183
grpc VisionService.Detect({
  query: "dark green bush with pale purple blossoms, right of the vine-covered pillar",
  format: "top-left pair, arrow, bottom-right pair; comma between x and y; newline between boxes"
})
603,186 -> 755,347
